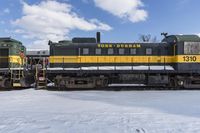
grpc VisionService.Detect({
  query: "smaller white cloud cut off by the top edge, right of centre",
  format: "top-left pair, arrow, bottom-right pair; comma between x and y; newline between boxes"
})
94,0 -> 148,23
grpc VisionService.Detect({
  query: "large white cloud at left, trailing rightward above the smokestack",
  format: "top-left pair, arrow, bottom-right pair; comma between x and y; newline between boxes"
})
12,0 -> 112,48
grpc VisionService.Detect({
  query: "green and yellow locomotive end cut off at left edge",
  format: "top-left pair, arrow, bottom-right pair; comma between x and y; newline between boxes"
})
0,38 -> 32,88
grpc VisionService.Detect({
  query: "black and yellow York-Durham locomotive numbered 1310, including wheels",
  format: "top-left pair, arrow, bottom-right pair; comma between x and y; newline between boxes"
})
45,32 -> 200,89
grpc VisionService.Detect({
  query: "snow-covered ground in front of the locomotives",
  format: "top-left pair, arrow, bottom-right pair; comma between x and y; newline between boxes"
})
0,89 -> 200,133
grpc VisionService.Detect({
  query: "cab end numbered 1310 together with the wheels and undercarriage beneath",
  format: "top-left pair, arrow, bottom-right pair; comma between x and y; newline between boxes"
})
163,35 -> 200,88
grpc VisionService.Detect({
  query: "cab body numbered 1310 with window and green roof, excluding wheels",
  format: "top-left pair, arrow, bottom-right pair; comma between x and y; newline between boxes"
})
163,35 -> 200,71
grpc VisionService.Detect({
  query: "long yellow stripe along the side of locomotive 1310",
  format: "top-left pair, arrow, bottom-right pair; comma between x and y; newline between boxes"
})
50,55 -> 200,63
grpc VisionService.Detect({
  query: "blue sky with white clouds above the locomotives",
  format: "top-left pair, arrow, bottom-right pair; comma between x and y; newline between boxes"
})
0,0 -> 200,49
